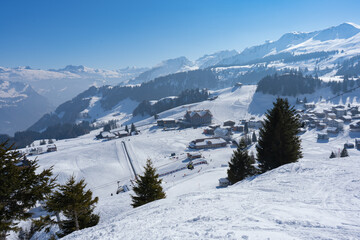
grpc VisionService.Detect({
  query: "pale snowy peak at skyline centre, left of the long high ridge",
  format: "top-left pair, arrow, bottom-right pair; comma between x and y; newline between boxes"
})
129,57 -> 197,84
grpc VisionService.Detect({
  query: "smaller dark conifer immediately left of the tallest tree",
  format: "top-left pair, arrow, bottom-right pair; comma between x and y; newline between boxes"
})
227,144 -> 256,184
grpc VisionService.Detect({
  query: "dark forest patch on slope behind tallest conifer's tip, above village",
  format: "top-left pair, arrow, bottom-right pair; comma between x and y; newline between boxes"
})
256,70 -> 322,96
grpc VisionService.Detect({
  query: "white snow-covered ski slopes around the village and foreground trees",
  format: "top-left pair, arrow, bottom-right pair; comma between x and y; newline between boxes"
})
15,83 -> 360,239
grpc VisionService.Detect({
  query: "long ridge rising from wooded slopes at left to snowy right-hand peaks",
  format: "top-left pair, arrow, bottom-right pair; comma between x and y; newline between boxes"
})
8,23 -> 360,135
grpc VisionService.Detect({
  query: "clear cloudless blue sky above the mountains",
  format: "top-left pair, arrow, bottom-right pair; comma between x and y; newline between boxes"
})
0,0 -> 360,69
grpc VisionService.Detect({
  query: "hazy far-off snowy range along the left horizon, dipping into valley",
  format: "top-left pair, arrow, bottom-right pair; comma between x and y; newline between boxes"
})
0,65 -> 147,106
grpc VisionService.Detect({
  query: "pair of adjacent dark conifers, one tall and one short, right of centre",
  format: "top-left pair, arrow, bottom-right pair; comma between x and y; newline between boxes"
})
227,98 -> 302,184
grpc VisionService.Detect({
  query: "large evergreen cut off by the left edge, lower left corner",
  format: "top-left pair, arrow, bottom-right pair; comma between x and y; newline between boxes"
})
0,142 -> 54,239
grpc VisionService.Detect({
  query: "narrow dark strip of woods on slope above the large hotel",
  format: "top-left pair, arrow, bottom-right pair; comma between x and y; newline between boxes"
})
133,89 -> 209,116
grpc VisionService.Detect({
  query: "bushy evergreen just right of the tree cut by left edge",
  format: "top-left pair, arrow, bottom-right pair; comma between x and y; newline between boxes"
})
46,176 -> 99,236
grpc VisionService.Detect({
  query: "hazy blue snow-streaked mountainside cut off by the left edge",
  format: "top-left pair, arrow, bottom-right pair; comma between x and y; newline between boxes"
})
0,80 -> 51,134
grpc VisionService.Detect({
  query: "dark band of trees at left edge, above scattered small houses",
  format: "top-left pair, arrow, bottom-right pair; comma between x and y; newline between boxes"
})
0,121 -> 94,148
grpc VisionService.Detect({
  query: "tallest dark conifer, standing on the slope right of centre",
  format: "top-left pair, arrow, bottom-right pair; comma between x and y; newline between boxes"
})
256,98 -> 302,172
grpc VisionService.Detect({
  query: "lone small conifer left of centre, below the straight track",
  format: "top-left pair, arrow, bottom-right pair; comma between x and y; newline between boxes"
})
131,159 -> 166,208
